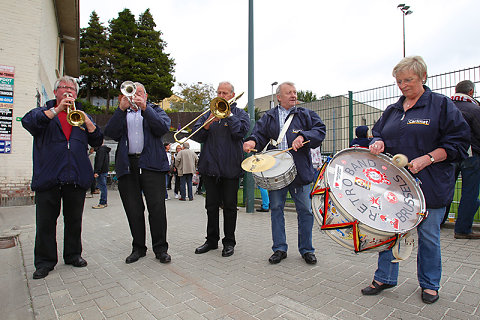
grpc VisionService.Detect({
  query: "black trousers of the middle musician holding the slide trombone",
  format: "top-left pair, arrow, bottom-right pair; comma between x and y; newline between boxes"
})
203,176 -> 239,246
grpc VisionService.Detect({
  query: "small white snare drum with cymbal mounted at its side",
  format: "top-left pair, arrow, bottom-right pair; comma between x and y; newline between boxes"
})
252,149 -> 297,190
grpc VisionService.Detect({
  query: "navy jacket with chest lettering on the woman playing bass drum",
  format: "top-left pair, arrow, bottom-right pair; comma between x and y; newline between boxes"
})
372,86 -> 470,209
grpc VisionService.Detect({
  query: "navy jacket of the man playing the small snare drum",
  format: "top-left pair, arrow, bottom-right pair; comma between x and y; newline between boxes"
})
246,106 -> 325,186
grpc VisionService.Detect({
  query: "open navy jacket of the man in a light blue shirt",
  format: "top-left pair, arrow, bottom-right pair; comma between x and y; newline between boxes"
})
105,101 -> 171,178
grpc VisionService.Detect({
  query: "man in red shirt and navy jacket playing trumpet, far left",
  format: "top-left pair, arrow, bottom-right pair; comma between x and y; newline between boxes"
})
22,76 -> 103,279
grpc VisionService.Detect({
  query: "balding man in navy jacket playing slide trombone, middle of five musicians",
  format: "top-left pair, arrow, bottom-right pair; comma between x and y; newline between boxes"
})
192,82 -> 250,257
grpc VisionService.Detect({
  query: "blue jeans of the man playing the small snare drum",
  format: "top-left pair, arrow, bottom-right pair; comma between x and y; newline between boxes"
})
269,185 -> 315,255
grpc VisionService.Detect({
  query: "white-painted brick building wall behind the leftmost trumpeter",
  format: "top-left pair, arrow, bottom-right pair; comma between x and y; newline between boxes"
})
0,0 -> 58,206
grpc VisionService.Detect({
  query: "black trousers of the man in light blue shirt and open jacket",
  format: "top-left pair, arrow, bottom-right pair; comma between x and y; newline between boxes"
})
118,156 -> 168,253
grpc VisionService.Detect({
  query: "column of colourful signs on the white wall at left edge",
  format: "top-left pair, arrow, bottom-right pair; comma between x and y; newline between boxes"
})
0,65 -> 15,153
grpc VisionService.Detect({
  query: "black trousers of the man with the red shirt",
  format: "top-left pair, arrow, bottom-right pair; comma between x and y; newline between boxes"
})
34,185 -> 86,269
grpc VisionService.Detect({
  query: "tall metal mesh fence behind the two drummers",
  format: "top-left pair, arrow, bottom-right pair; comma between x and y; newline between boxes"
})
248,66 -> 480,221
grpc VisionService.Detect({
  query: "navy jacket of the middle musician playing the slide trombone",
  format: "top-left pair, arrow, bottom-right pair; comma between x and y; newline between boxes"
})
192,103 -> 250,179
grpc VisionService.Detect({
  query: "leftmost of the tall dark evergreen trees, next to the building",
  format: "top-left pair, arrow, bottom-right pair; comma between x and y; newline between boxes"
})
80,11 -> 109,103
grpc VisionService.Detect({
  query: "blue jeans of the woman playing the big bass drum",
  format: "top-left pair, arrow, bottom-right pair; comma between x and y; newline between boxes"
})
374,207 -> 445,291
